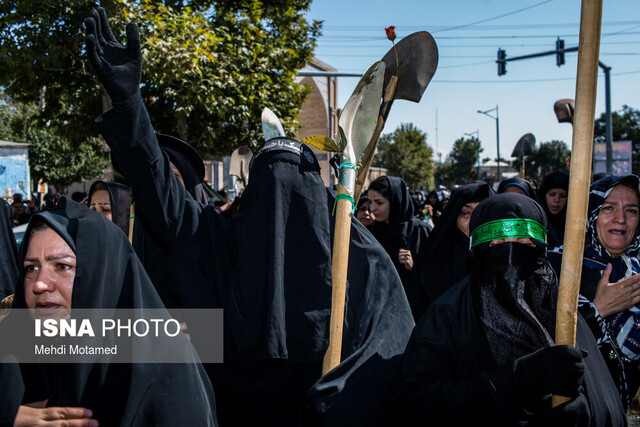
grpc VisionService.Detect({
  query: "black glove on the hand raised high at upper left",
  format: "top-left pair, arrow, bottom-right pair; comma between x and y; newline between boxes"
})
84,7 -> 142,111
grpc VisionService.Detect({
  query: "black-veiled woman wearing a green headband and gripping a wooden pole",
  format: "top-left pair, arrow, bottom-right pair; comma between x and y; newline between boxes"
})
398,193 -> 626,426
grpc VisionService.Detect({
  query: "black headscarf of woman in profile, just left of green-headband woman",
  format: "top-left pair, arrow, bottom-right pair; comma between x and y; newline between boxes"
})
416,181 -> 494,306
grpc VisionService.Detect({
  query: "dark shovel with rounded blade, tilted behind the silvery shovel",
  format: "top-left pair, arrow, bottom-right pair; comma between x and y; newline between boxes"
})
354,31 -> 438,200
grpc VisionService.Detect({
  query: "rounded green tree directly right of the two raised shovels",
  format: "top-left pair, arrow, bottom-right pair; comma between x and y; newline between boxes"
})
374,123 -> 434,189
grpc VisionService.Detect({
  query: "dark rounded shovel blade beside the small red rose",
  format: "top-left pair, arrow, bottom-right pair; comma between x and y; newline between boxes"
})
382,31 -> 438,102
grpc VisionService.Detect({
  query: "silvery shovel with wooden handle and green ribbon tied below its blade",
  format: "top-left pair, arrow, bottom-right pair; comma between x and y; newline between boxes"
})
322,61 -> 385,375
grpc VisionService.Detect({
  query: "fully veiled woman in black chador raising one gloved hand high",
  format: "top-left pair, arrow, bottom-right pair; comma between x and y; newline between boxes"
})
85,9 -> 413,426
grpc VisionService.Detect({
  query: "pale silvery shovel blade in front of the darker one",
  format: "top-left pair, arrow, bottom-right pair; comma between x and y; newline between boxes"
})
338,61 -> 385,162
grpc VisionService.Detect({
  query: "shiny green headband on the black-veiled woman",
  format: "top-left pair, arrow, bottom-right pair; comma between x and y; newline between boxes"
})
470,218 -> 547,248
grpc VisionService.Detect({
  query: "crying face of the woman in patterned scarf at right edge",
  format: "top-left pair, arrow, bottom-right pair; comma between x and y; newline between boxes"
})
596,185 -> 640,256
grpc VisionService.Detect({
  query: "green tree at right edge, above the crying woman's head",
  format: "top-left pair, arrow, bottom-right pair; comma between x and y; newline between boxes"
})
594,105 -> 640,175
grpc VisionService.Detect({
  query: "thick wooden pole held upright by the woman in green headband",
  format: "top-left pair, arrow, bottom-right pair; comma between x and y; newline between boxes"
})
553,0 -> 602,406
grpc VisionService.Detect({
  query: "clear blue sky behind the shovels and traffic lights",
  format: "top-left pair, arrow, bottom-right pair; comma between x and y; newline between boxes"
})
307,0 -> 640,164
